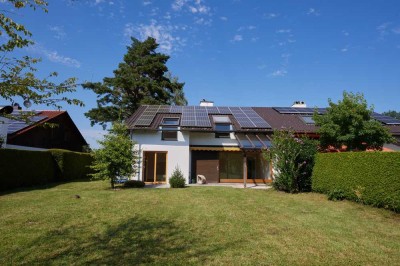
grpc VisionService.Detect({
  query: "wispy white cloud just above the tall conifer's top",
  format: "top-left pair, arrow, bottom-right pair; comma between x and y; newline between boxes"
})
124,20 -> 185,54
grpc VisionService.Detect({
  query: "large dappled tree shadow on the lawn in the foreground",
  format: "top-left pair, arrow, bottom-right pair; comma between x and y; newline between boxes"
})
14,218 -> 233,265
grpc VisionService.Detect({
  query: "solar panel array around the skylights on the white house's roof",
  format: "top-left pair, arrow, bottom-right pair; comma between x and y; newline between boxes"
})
134,105 -> 271,128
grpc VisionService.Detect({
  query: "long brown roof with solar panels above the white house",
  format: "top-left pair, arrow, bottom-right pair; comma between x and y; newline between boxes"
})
126,105 -> 400,135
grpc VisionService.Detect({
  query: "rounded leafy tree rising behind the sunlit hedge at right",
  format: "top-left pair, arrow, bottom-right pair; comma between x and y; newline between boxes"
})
314,91 -> 394,151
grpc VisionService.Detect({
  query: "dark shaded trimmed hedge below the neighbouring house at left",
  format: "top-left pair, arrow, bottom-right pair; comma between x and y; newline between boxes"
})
0,149 -> 93,191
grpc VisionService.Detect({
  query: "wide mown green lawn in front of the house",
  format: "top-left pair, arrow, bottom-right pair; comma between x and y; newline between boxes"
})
0,181 -> 400,265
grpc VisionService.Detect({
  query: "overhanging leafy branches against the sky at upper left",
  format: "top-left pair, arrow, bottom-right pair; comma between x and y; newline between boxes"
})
0,0 -> 83,107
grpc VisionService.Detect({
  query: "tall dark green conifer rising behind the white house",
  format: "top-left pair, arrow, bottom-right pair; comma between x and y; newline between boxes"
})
83,37 -> 187,127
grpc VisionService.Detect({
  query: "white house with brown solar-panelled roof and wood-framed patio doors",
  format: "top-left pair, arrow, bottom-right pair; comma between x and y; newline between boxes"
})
126,101 -> 400,183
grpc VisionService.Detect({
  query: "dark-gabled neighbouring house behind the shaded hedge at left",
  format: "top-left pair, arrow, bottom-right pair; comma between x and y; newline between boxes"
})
6,110 -> 87,151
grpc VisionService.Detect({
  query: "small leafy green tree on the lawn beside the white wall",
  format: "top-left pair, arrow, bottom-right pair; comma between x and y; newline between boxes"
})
91,122 -> 137,188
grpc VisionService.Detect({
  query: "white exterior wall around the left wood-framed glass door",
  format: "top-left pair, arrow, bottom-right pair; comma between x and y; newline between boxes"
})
131,130 -> 190,184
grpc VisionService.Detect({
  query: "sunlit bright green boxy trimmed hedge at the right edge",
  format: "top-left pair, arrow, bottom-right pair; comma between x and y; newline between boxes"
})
312,152 -> 400,212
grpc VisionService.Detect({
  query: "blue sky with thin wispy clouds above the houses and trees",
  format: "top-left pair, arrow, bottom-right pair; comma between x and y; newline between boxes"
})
0,0 -> 400,147
